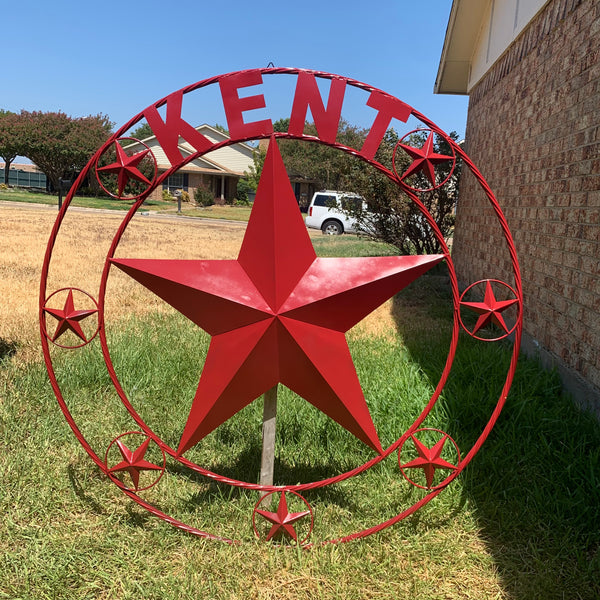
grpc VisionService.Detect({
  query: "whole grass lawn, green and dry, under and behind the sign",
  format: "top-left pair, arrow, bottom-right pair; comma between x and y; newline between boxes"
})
0,206 -> 600,600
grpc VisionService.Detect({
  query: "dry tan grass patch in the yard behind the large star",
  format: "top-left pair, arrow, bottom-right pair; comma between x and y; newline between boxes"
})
0,205 -> 394,361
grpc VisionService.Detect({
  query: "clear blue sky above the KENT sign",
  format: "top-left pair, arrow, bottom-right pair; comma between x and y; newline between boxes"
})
0,0 -> 467,136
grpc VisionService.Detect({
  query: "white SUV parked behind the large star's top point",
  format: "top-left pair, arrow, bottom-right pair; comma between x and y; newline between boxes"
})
305,190 -> 366,235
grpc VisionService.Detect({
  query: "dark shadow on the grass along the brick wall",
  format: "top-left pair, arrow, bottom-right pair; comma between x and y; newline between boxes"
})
394,277 -> 600,600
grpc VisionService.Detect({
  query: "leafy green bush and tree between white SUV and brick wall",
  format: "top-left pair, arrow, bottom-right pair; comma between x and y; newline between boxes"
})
268,119 -> 460,254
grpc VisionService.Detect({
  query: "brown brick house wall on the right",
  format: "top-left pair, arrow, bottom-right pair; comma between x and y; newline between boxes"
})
453,0 -> 600,398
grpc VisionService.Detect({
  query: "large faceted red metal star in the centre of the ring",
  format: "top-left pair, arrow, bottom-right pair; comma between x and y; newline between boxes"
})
112,140 -> 443,454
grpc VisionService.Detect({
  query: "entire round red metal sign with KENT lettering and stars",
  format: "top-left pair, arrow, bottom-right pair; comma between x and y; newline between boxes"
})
39,67 -> 523,546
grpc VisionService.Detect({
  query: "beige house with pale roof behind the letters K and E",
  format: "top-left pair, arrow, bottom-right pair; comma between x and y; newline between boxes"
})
130,125 -> 254,204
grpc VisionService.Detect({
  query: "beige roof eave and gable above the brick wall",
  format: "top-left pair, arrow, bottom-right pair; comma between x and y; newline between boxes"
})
433,0 -> 549,94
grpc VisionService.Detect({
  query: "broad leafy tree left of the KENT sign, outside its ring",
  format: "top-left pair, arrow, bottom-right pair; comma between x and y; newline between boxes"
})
20,111 -> 112,190
